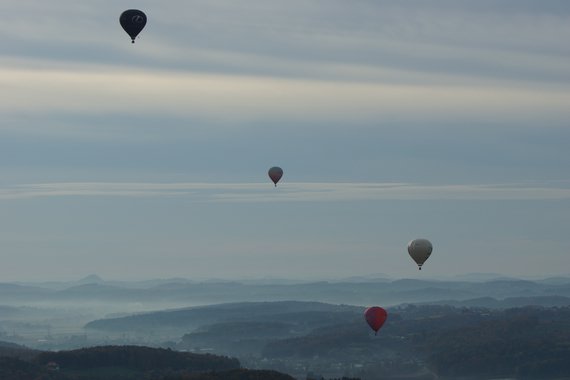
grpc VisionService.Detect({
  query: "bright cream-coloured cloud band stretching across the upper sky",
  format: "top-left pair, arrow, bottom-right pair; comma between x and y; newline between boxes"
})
0,59 -> 570,132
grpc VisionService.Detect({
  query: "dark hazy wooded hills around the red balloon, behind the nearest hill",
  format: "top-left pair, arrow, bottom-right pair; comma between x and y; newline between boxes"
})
87,297 -> 570,380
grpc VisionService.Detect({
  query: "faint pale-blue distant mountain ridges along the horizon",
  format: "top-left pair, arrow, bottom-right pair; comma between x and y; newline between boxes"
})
0,275 -> 570,309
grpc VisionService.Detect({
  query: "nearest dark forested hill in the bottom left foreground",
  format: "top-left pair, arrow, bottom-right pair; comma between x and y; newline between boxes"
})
0,346 -> 293,380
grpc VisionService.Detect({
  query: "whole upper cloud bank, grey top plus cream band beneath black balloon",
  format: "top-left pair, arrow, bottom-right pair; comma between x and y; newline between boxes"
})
4,0 -> 570,140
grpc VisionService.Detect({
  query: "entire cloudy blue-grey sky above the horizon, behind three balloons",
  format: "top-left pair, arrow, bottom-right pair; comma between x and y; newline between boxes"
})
0,0 -> 570,282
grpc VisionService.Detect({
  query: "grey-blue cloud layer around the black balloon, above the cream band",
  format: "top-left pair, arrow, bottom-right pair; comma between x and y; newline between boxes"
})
4,0 -> 570,82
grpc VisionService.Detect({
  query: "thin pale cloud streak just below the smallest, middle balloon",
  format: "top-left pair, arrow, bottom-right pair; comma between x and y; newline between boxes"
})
0,182 -> 570,203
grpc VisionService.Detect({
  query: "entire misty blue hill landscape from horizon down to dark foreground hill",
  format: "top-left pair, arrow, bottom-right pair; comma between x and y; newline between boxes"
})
0,276 -> 570,379
